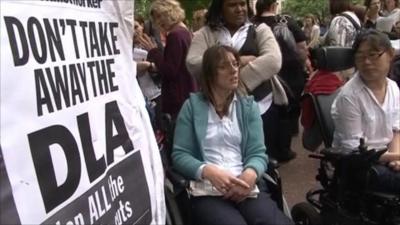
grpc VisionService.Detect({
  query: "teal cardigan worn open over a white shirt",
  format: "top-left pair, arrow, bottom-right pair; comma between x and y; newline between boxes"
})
172,93 -> 268,180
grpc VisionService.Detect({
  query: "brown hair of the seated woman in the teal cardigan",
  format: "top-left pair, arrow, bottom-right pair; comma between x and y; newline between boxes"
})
200,45 -> 240,102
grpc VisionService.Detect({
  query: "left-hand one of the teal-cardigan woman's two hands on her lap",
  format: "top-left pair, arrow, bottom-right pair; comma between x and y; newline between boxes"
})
202,164 -> 250,195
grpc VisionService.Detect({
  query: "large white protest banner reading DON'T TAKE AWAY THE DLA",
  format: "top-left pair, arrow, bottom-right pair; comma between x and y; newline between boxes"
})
0,0 -> 165,225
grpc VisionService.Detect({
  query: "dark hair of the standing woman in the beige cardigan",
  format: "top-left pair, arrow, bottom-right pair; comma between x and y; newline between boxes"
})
206,0 -> 254,30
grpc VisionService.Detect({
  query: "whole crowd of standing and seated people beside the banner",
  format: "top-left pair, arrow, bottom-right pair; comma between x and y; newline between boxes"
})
133,0 -> 400,224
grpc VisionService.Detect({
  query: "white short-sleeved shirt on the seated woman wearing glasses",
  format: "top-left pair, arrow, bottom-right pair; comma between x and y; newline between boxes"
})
331,73 -> 400,149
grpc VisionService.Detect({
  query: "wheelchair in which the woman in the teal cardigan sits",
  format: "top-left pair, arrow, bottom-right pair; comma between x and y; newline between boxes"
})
156,115 -> 290,225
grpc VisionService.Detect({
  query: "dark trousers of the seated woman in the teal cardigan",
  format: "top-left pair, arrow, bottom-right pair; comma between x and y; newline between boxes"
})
191,192 -> 294,225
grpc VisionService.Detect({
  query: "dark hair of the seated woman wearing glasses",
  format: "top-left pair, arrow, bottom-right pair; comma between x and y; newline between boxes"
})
353,29 -> 392,54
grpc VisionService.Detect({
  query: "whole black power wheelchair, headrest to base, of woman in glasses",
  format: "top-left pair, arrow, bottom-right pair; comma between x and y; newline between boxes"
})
291,47 -> 400,225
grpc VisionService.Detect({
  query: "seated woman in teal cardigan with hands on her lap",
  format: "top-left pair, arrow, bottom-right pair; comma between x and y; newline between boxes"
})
172,45 -> 293,225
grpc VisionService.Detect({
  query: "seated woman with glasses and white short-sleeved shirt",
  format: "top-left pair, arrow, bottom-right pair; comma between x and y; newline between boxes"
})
331,30 -> 400,193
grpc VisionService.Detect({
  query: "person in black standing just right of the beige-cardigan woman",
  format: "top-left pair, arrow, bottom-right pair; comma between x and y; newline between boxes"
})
254,0 -> 307,161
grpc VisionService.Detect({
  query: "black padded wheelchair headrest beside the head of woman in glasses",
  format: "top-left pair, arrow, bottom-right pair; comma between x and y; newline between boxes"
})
311,46 -> 354,72
